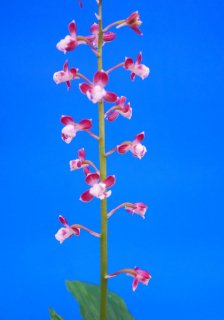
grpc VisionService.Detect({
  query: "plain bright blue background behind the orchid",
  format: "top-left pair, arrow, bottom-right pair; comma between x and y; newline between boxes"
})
0,0 -> 224,320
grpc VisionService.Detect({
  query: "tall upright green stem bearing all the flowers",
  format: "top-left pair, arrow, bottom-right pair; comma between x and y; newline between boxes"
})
97,0 -> 108,320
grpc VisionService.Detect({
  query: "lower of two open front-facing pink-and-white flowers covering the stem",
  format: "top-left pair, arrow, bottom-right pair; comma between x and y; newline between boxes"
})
80,172 -> 115,202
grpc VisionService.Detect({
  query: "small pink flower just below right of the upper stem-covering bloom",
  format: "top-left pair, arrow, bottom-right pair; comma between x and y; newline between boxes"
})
105,96 -> 132,122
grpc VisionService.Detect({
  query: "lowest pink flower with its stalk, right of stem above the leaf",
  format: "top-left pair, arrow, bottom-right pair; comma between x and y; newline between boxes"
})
105,267 -> 151,291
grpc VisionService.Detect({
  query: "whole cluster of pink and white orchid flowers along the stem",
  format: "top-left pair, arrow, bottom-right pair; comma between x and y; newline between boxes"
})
53,5 -> 151,304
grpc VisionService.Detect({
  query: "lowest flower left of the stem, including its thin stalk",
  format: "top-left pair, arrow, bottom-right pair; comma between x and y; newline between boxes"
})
55,215 -> 100,244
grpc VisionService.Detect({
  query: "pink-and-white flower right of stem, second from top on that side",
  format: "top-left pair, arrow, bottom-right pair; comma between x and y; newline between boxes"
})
124,52 -> 150,80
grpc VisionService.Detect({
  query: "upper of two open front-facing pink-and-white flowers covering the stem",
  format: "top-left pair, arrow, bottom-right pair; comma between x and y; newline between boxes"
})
79,70 -> 117,103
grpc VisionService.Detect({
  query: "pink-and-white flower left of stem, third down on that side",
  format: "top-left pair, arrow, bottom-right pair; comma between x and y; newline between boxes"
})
60,115 -> 92,143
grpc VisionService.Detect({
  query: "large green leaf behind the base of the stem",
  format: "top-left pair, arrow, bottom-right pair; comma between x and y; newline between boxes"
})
66,281 -> 134,320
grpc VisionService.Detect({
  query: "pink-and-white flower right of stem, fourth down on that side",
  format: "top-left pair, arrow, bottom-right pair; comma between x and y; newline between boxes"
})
117,132 -> 147,159
